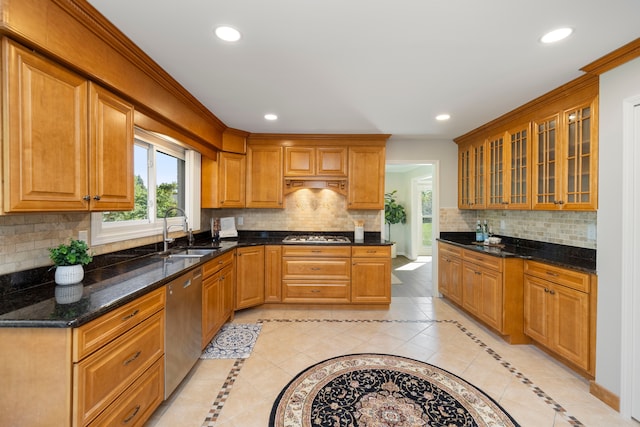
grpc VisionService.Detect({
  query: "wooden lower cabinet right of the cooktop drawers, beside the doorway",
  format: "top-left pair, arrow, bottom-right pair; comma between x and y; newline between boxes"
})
351,246 -> 391,304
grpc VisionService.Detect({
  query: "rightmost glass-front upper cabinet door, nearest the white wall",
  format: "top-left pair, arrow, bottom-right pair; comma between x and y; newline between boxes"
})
563,101 -> 598,210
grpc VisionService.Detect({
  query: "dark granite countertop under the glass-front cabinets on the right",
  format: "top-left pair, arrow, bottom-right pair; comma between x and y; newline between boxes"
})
437,232 -> 596,274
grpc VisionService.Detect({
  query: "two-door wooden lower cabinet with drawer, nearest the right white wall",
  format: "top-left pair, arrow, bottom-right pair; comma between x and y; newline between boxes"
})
524,261 -> 595,375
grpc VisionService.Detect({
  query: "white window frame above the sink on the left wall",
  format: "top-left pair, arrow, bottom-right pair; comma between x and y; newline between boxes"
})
90,128 -> 201,246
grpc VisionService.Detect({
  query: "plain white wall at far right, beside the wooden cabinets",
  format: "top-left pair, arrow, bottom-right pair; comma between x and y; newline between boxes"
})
596,59 -> 640,404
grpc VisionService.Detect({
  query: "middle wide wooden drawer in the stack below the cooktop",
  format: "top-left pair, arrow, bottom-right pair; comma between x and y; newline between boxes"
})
282,258 -> 351,280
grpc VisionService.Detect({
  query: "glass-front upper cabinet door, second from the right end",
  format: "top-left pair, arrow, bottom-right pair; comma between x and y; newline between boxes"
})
532,114 -> 561,210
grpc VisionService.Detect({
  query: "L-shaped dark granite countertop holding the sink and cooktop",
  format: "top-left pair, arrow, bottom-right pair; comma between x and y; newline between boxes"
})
0,231 -> 390,328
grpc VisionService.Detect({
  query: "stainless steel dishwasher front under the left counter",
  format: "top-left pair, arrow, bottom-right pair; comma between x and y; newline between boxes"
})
164,268 -> 202,400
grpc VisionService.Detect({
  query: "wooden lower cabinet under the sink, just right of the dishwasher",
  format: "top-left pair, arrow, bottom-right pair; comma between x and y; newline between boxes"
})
202,252 -> 235,349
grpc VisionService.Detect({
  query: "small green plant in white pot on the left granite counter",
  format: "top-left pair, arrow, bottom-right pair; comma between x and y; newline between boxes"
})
49,239 -> 93,285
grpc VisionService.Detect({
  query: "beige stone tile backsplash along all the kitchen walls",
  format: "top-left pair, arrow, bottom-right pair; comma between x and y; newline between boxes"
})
0,190 -> 597,274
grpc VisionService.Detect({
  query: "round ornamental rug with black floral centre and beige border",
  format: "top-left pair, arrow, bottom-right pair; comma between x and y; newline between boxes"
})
269,354 -> 519,427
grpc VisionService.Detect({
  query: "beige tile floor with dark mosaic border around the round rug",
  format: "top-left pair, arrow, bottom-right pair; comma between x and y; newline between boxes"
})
145,260 -> 640,427
